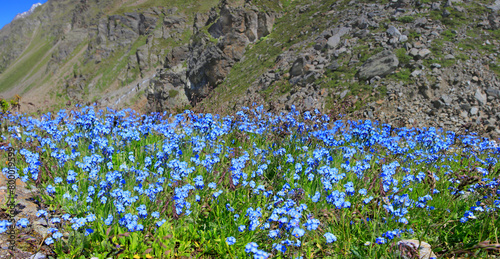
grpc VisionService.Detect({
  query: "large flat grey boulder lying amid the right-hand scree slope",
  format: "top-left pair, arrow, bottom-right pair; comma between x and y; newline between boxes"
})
358,50 -> 399,80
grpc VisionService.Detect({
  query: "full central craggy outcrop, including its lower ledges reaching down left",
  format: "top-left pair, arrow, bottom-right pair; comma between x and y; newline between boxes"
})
147,3 -> 277,111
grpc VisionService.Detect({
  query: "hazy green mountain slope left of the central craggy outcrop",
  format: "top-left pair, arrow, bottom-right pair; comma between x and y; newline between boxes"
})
0,0 -> 221,111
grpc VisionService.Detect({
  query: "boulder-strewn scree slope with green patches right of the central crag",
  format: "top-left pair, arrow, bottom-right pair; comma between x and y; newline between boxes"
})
148,0 -> 500,139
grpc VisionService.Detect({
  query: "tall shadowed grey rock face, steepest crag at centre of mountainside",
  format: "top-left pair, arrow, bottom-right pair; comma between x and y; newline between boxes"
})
185,5 -> 275,104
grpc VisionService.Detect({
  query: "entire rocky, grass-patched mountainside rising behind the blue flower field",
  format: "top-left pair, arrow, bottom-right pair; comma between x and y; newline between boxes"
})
0,0 -> 500,139
